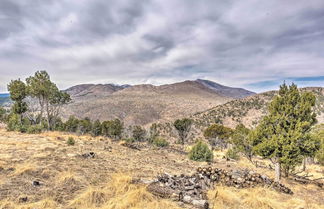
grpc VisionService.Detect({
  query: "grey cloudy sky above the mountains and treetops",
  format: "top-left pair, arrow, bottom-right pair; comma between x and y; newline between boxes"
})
0,0 -> 324,92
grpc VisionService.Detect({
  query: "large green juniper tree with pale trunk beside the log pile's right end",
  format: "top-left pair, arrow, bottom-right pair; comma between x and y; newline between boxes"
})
251,84 -> 316,181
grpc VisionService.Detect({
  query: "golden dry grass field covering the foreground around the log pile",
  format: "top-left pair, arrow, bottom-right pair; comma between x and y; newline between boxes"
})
0,129 -> 324,209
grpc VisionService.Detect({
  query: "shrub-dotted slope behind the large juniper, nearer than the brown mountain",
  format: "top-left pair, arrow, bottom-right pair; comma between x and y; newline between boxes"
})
192,87 -> 324,128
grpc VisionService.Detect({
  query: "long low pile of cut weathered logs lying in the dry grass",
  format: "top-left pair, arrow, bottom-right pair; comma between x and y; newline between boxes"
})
148,167 -> 293,209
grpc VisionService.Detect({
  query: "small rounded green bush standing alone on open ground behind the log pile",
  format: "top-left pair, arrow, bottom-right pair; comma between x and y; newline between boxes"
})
189,141 -> 214,162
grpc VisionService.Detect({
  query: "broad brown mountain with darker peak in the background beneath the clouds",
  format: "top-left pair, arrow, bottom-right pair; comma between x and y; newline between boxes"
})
62,80 -> 254,125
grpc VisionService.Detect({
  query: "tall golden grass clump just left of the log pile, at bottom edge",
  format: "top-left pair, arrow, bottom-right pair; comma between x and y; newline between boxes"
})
69,174 -> 179,209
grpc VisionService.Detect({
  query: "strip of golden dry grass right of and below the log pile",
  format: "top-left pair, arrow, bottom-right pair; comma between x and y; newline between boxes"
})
208,186 -> 321,209
